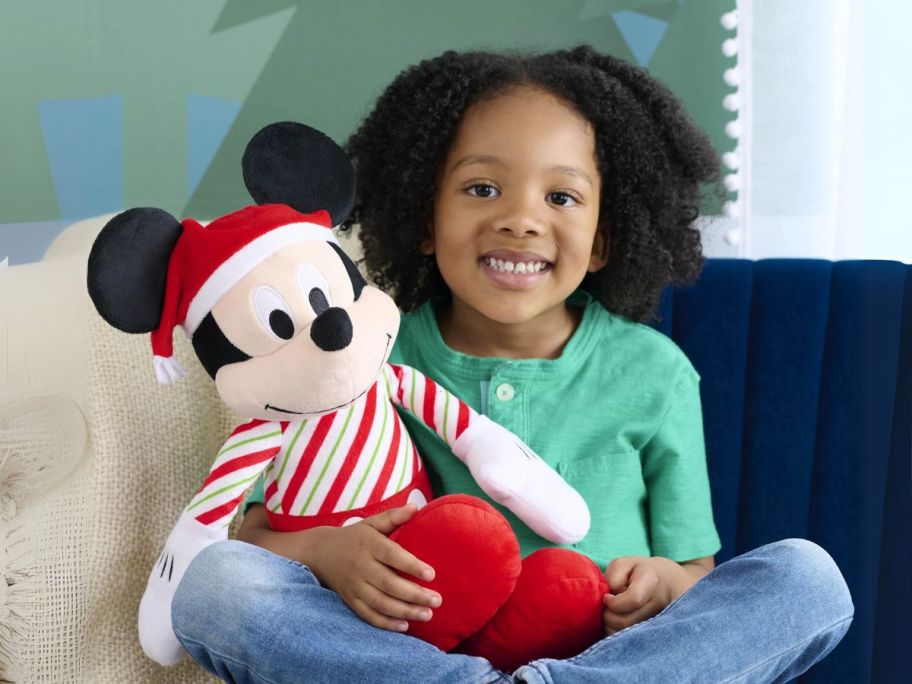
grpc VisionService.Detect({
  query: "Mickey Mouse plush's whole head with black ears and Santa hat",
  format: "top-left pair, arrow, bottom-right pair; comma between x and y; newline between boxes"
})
88,122 -> 399,420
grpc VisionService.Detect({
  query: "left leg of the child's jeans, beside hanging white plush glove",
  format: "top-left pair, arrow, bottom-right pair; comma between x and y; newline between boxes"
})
171,541 -> 509,684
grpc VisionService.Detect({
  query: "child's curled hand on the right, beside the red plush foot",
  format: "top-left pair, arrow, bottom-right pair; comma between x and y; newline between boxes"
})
602,556 -> 677,635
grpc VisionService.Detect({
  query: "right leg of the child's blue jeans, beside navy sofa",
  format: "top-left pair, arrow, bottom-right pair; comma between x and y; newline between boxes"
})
514,539 -> 854,684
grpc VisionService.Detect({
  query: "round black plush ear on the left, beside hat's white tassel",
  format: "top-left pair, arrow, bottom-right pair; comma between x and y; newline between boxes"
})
88,209 -> 183,333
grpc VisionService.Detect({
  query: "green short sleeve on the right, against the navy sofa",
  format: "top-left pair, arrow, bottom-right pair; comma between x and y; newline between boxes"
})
642,364 -> 721,562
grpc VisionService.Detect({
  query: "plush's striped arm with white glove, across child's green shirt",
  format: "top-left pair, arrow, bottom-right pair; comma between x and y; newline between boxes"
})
385,364 -> 589,544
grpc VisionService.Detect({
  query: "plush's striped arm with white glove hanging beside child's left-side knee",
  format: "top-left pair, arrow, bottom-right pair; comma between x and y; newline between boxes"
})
139,420 -> 282,665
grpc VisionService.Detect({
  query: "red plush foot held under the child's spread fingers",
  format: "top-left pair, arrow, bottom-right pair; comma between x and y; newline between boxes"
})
390,494 -> 522,651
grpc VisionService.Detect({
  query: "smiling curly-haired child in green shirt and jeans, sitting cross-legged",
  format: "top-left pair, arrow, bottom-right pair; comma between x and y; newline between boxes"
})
172,47 -> 853,683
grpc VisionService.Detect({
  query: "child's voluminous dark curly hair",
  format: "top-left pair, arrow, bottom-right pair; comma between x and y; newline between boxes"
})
347,46 -> 719,321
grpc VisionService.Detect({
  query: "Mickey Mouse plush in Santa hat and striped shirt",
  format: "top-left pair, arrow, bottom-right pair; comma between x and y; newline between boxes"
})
88,123 -> 607,668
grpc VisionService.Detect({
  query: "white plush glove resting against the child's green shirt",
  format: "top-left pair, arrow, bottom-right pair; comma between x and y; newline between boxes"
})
453,416 -> 589,544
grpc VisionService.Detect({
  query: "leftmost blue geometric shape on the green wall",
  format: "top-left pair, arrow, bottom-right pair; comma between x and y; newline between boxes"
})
38,95 -> 124,219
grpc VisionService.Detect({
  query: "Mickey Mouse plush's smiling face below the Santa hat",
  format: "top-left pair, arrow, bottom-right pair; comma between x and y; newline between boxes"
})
200,241 -> 399,420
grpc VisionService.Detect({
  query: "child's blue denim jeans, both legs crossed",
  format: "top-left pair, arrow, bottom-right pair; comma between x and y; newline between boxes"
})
171,539 -> 854,684
